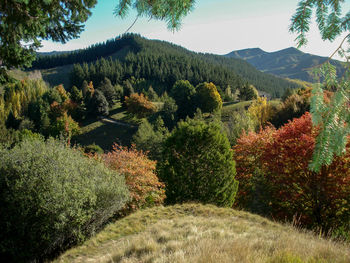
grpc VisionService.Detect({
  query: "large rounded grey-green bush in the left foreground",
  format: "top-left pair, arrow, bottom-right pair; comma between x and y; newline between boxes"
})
0,138 -> 129,262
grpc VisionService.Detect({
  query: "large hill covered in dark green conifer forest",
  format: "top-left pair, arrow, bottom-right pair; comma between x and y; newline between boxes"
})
33,34 -> 299,97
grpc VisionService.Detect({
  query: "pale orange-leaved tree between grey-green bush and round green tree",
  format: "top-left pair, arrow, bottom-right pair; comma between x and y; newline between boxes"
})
102,144 -> 165,214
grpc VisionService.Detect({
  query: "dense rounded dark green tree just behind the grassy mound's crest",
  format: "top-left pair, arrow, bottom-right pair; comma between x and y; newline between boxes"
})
158,120 -> 238,207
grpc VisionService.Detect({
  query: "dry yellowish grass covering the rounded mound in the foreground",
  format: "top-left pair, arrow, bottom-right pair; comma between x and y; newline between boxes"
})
57,204 -> 350,263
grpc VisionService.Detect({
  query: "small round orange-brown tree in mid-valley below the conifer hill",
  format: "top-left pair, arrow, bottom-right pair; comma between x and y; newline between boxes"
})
125,93 -> 156,118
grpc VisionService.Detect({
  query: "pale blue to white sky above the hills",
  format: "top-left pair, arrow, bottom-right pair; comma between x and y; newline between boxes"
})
39,0 -> 350,58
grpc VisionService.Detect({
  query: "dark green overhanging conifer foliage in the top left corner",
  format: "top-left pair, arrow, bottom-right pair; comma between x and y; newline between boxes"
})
0,0 -> 97,67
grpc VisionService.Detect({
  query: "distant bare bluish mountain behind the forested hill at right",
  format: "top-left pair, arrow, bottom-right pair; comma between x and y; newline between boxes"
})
225,47 -> 344,82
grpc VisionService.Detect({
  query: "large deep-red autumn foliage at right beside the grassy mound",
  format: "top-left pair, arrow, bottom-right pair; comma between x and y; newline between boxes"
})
235,113 -> 350,229
